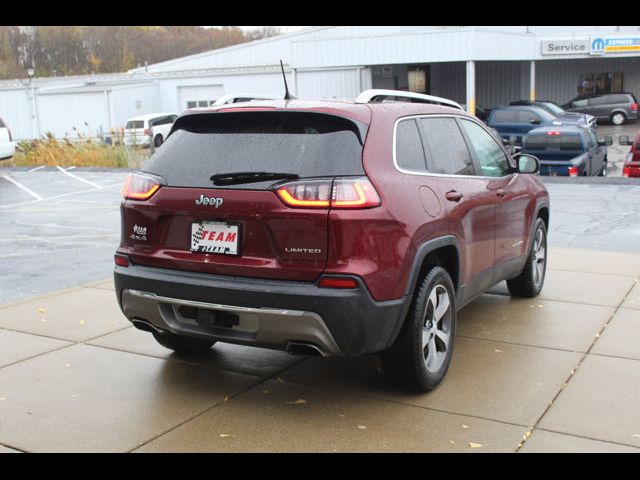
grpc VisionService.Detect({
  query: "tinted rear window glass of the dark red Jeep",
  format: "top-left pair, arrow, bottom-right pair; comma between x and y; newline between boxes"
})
143,111 -> 365,189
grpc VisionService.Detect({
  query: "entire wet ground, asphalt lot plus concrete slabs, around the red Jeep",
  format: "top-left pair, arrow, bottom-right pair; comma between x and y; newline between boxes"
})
0,137 -> 640,452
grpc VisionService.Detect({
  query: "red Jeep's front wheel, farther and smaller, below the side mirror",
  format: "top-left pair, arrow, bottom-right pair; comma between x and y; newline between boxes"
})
507,218 -> 547,298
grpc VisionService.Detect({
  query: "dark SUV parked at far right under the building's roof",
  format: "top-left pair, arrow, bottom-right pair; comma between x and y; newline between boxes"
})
562,93 -> 638,125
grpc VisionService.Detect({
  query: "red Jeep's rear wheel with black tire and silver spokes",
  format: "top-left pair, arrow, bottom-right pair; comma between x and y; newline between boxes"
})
381,267 -> 456,392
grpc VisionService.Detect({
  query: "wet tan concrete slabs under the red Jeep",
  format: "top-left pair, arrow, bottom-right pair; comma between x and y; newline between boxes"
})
0,247 -> 640,453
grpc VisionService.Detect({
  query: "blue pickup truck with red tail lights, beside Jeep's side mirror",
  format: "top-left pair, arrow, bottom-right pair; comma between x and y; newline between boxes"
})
521,125 -> 613,177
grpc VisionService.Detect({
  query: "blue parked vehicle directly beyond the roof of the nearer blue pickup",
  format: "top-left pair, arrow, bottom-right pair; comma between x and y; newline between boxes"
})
487,105 -> 562,146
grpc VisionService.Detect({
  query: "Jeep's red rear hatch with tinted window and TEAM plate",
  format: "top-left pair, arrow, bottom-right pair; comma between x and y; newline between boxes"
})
120,110 -> 366,281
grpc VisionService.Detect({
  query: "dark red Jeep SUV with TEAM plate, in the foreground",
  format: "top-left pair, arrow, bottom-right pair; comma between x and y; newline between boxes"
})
115,90 -> 549,391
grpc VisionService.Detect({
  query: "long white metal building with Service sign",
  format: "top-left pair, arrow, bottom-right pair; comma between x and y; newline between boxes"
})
0,26 -> 640,139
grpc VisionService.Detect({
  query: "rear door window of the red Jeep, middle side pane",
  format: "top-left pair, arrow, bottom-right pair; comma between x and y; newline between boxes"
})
418,117 -> 474,175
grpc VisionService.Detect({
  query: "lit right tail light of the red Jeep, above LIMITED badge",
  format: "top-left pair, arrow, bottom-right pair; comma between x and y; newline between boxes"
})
276,177 -> 381,208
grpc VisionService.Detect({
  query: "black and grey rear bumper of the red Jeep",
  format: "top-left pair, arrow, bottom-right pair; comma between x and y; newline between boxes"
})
114,265 -> 411,356
